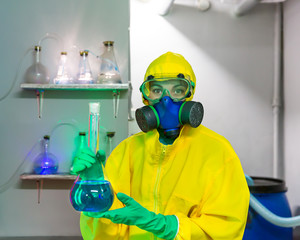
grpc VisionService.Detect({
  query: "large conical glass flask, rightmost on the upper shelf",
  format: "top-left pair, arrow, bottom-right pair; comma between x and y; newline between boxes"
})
97,41 -> 122,84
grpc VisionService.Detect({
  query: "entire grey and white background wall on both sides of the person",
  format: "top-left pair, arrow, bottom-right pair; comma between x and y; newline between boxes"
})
0,0 -> 300,236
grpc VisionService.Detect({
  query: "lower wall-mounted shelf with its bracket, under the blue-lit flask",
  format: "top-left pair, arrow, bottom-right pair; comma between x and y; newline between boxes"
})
20,173 -> 77,203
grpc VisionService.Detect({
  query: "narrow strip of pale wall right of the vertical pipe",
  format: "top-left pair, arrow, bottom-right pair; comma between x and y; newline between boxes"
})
284,1 -> 300,219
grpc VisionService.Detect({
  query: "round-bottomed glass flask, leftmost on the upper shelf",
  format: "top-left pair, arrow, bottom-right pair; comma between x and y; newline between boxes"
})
25,46 -> 50,84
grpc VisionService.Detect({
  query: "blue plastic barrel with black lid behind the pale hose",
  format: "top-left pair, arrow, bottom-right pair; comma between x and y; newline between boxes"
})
243,177 -> 293,240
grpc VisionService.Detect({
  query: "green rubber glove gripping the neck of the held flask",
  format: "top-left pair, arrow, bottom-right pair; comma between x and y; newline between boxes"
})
71,148 -> 106,180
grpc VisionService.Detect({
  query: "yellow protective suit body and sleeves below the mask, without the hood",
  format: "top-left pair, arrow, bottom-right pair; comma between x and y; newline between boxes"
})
80,125 -> 249,240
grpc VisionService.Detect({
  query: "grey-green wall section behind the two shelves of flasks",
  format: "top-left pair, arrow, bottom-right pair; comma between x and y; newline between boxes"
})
0,0 -> 129,236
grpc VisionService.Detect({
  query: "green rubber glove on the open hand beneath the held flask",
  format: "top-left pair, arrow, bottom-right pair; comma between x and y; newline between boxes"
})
84,193 -> 178,240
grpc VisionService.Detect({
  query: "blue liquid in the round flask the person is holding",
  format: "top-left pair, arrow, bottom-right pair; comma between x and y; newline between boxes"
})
70,180 -> 114,212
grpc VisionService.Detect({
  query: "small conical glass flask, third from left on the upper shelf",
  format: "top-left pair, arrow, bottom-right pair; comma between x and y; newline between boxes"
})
77,51 -> 94,84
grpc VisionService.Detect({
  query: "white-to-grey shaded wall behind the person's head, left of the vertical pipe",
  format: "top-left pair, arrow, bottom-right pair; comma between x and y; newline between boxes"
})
130,0 -> 275,176
